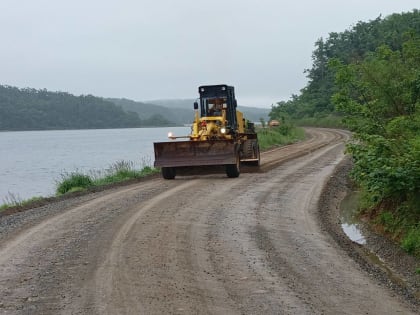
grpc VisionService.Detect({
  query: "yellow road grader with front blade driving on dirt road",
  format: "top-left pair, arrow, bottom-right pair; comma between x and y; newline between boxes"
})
154,84 -> 260,179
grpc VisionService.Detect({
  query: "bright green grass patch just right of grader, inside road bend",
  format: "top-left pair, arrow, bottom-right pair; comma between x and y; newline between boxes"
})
257,124 -> 305,151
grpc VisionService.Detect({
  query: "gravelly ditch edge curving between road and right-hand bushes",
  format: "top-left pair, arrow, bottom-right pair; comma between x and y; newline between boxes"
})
317,156 -> 420,309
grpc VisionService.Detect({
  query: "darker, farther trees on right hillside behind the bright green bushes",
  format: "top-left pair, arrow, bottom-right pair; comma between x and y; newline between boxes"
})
270,10 -> 420,119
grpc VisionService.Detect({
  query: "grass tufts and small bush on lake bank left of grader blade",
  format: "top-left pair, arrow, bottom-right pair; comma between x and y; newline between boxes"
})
56,161 -> 159,195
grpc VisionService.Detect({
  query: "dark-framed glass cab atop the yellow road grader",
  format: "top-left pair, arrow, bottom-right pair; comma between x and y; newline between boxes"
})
198,84 -> 237,130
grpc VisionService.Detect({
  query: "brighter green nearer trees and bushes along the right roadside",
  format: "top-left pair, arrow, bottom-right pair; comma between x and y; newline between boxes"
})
331,34 -> 420,257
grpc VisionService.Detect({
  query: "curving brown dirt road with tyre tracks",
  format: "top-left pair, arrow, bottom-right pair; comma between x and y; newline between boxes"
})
0,129 -> 413,314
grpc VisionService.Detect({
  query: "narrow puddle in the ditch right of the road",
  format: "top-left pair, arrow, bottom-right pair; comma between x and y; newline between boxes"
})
340,191 -> 366,245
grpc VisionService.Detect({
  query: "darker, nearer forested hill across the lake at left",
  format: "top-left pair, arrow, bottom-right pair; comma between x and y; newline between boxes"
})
0,85 -> 174,130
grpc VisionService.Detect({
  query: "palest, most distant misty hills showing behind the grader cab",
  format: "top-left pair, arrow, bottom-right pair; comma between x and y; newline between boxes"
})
147,99 -> 271,123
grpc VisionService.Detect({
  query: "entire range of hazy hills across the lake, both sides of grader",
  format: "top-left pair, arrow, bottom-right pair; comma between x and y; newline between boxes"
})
0,85 -> 269,130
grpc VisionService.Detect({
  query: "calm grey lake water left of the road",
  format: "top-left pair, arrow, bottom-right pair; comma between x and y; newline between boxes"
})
0,127 -> 190,204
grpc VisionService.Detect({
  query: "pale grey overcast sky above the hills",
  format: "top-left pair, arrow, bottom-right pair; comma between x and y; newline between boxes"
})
0,0 -> 419,107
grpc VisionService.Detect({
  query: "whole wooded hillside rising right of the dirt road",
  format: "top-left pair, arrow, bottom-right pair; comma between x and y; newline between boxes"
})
270,10 -> 420,257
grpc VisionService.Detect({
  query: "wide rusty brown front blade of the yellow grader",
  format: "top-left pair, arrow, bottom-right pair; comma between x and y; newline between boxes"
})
154,140 -> 237,167
